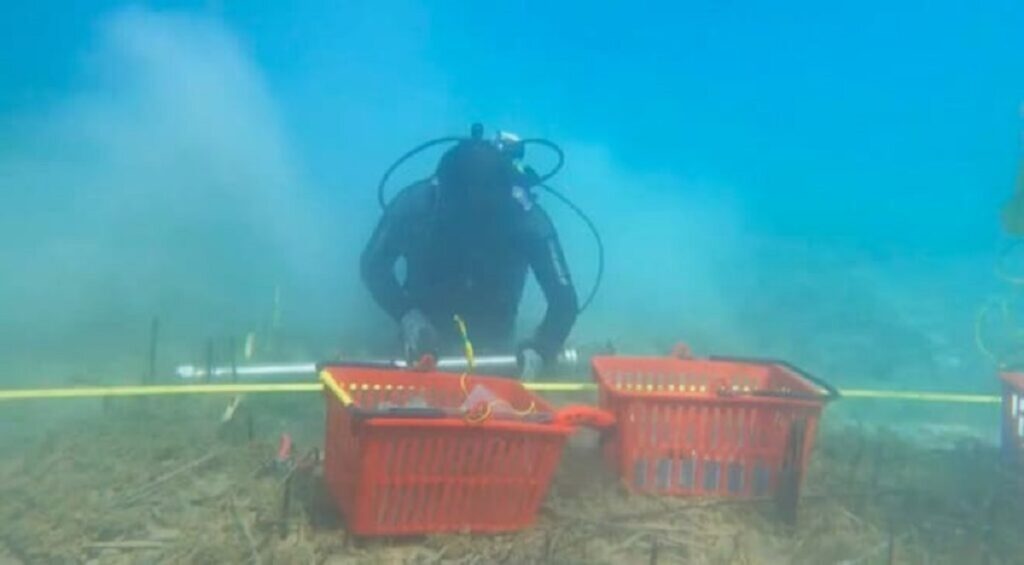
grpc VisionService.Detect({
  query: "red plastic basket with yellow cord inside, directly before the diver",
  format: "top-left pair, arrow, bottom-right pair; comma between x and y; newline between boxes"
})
321,365 -> 573,535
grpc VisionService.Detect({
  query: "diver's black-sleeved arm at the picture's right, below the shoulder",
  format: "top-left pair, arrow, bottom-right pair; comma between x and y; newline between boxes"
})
525,229 -> 578,362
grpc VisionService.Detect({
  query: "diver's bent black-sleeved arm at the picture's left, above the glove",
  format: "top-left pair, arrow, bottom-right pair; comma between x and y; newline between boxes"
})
359,209 -> 413,320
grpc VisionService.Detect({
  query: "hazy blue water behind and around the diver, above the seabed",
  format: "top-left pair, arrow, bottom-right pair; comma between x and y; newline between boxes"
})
0,0 -> 1024,559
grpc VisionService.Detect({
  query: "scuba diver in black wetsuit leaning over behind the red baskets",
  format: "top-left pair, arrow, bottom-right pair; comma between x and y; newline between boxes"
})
360,125 -> 596,380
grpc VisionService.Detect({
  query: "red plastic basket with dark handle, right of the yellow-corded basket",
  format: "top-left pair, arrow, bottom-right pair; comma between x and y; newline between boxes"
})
592,355 -> 838,497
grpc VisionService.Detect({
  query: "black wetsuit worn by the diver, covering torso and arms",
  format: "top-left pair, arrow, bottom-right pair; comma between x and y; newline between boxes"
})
361,181 -> 578,361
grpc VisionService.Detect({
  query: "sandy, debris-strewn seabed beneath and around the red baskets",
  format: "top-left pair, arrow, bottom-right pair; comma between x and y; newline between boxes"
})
0,395 -> 1024,565
